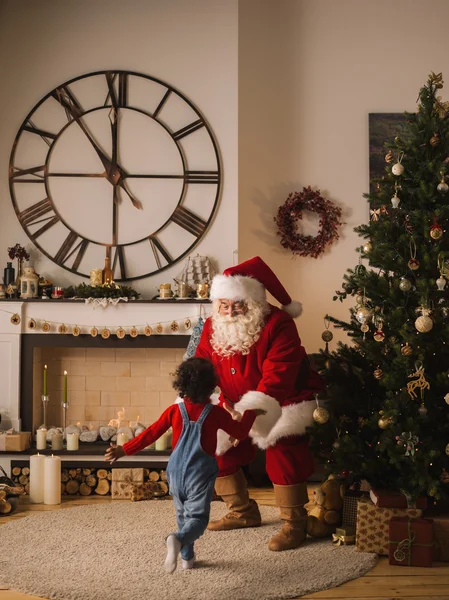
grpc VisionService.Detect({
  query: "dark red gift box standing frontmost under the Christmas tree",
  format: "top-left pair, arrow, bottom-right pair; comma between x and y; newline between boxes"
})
388,517 -> 433,567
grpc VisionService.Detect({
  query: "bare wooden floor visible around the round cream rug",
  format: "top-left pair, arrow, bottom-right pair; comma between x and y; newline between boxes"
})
0,488 -> 449,600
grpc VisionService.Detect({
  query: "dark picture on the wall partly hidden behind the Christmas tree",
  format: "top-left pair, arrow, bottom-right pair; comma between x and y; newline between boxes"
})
369,113 -> 406,193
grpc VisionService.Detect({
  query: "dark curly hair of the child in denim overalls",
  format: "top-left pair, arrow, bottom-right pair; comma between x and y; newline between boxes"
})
173,356 -> 218,404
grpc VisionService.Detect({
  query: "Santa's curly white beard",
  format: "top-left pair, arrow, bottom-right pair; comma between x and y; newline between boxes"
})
211,302 -> 270,357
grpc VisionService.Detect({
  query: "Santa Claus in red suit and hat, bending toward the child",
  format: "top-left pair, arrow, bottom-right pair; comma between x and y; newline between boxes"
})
196,256 -> 322,551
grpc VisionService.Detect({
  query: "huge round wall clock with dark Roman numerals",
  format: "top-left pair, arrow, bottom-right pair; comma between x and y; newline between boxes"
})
9,71 -> 222,281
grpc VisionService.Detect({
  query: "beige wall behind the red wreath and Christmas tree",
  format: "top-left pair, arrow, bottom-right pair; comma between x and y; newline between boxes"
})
239,0 -> 449,352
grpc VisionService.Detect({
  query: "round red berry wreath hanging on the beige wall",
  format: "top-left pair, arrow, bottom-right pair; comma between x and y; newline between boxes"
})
274,186 -> 342,258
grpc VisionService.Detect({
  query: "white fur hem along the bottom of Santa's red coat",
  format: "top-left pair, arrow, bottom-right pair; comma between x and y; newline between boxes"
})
253,400 -> 316,450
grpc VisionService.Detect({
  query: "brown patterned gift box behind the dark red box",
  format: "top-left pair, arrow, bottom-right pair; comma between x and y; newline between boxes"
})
355,497 -> 422,556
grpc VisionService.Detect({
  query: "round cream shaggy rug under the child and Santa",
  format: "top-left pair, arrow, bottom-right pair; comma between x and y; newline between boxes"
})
0,500 -> 377,600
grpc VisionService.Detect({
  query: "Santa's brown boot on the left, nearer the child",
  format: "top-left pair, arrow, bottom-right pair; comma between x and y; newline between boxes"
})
207,469 -> 261,531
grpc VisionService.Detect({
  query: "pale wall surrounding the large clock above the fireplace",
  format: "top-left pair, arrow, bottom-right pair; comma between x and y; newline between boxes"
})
0,0 -> 238,296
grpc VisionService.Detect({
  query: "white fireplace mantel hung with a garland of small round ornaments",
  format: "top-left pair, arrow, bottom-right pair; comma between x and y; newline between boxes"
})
0,300 -> 211,430
